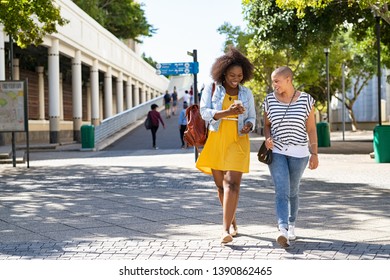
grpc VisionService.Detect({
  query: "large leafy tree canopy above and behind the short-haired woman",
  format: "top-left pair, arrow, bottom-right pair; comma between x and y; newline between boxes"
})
244,0 -> 390,130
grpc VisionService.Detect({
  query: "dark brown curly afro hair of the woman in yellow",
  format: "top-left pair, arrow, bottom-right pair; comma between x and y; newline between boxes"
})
211,47 -> 254,83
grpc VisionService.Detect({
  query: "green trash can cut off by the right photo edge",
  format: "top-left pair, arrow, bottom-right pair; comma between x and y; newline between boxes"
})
374,125 -> 390,163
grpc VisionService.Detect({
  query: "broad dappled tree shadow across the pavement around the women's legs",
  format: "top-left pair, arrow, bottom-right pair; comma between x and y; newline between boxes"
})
0,164 -> 390,258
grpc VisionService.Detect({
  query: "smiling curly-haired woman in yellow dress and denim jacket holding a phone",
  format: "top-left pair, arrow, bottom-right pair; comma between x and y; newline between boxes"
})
196,47 -> 256,243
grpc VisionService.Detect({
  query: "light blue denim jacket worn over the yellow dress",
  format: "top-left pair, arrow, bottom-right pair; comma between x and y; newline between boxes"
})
200,84 -> 256,136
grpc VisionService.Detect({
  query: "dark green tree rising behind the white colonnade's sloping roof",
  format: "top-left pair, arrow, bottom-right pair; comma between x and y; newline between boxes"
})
73,0 -> 156,42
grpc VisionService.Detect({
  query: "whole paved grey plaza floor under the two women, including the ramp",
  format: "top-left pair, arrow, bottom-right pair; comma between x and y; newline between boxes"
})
0,107 -> 390,260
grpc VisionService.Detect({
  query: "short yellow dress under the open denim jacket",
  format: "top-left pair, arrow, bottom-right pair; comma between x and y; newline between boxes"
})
196,94 -> 250,174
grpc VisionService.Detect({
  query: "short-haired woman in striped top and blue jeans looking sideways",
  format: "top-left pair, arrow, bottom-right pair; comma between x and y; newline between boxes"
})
263,66 -> 318,247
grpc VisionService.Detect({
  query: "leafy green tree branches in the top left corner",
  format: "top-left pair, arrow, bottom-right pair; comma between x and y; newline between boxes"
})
0,0 -> 68,48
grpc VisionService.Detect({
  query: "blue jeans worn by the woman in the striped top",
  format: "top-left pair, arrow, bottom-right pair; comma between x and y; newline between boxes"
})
268,153 -> 309,228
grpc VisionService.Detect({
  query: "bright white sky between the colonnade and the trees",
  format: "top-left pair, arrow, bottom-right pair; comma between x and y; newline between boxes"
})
139,0 -> 245,86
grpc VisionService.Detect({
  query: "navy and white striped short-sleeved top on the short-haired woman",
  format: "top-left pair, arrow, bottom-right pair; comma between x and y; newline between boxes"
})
263,92 -> 315,156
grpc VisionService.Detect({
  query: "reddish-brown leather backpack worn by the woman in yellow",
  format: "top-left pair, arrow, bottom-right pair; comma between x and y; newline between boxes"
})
183,83 -> 215,148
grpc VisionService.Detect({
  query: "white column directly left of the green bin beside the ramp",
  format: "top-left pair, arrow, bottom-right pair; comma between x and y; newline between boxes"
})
72,50 -> 83,142
